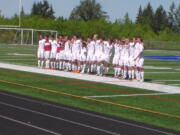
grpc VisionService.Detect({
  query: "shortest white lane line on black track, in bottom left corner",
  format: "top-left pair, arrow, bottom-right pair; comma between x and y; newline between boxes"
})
0,115 -> 61,135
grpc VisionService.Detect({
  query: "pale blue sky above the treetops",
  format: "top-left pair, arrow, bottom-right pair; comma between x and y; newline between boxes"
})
0,0 -> 180,21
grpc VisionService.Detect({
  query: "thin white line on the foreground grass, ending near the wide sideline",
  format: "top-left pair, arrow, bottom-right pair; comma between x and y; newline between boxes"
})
85,93 -> 178,98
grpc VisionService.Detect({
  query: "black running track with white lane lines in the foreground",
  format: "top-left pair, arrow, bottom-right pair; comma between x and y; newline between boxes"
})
0,90 -> 180,135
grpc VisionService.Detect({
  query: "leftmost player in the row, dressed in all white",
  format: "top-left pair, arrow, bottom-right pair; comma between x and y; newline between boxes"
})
37,35 -> 45,68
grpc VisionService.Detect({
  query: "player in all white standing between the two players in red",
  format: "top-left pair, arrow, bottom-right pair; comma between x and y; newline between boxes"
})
50,36 -> 57,69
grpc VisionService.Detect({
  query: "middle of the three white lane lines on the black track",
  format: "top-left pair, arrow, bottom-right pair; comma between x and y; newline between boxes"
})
0,101 -> 120,135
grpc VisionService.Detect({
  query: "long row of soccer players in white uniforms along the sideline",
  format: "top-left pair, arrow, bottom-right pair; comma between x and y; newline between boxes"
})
38,35 -> 144,81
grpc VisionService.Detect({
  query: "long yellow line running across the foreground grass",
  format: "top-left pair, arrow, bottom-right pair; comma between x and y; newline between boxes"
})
0,80 -> 180,119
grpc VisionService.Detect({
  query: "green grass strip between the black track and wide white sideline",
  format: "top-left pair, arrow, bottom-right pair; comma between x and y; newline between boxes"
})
0,69 -> 180,131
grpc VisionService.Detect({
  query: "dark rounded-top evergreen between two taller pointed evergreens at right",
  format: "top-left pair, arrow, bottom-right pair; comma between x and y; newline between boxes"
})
153,5 -> 168,32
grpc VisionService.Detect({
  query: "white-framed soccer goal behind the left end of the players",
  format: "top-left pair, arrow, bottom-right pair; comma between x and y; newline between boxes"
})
0,27 -> 58,45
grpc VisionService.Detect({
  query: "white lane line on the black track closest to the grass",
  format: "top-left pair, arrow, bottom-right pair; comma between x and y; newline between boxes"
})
0,92 -> 173,135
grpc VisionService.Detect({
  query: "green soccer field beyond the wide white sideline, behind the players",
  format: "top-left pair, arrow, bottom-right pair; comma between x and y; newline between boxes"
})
0,45 -> 180,87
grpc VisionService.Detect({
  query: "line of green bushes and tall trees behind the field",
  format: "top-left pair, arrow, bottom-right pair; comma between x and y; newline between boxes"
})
0,0 -> 180,41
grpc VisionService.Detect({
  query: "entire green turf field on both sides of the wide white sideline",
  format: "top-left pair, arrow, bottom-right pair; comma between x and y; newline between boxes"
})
0,45 -> 180,131
